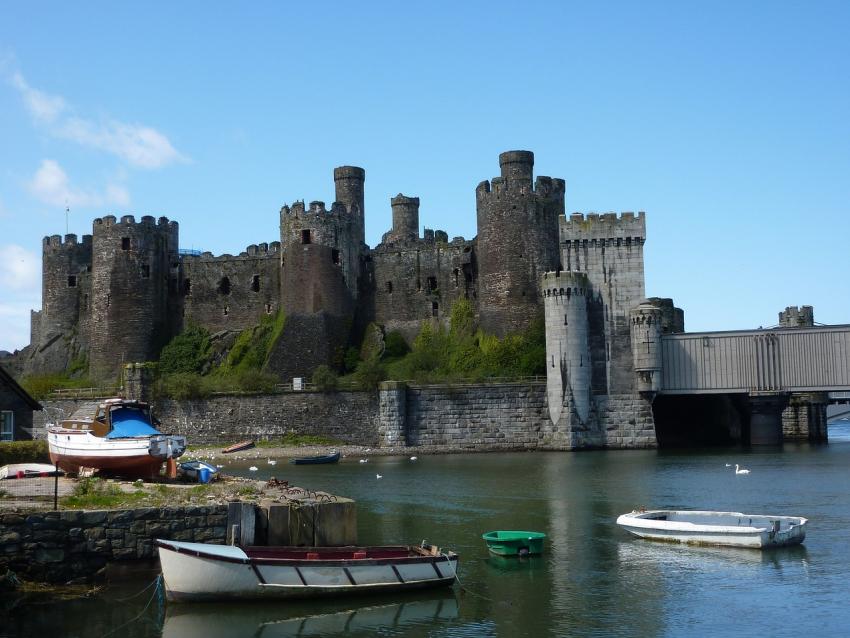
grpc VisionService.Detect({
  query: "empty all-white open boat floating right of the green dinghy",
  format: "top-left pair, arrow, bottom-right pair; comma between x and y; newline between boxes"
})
617,510 -> 808,548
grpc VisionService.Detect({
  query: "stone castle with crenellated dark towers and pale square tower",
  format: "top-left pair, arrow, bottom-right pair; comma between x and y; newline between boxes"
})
19,151 -> 684,444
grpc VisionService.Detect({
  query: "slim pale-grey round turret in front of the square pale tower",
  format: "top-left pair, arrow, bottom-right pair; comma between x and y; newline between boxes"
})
540,272 -> 593,426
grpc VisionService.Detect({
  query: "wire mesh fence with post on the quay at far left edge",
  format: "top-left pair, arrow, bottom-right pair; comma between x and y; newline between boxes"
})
0,463 -> 66,510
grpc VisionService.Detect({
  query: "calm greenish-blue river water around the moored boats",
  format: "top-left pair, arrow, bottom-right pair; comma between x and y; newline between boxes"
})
0,422 -> 850,638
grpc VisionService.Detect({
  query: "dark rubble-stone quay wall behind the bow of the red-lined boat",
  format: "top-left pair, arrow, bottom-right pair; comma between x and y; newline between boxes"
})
0,505 -> 227,583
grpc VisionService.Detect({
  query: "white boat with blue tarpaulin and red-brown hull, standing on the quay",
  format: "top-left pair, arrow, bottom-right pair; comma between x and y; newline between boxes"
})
47,399 -> 186,478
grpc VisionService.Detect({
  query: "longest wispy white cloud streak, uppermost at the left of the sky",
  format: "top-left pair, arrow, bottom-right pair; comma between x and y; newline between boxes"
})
11,72 -> 188,169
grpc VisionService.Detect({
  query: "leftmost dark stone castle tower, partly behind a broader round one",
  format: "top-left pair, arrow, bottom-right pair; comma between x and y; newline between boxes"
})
39,235 -> 92,339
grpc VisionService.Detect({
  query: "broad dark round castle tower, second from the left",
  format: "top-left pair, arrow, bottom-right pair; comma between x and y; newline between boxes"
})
90,215 -> 179,379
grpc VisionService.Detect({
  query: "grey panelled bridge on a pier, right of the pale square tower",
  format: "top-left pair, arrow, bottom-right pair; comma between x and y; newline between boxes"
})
658,325 -> 850,443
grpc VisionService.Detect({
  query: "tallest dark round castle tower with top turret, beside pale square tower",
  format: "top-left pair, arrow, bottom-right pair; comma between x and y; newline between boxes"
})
475,151 -> 564,335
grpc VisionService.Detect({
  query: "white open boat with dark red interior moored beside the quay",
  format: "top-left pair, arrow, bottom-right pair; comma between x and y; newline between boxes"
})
154,539 -> 458,602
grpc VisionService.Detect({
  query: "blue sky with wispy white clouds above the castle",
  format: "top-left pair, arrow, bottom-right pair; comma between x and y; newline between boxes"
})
0,0 -> 850,350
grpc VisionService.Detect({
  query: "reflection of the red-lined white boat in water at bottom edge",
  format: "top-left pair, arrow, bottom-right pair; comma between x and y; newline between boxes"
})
162,591 -> 458,638
